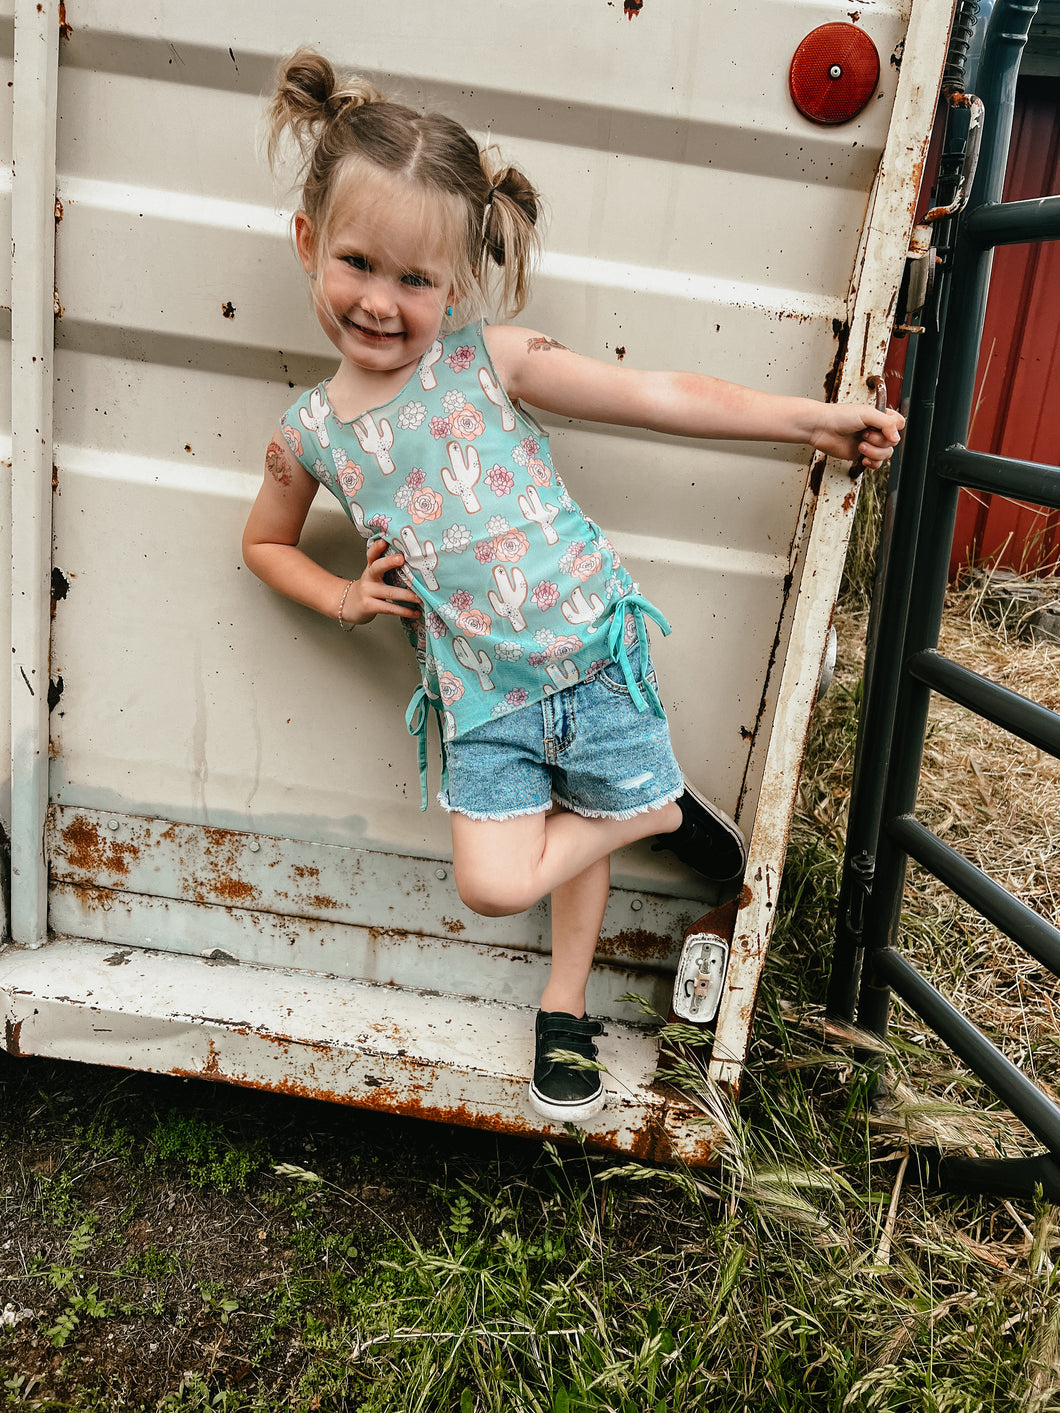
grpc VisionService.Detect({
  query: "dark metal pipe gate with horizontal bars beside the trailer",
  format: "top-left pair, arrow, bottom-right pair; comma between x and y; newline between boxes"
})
828,0 -> 1060,1201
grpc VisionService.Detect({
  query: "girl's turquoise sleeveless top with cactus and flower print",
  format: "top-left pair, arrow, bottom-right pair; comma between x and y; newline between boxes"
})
280,324 -> 669,798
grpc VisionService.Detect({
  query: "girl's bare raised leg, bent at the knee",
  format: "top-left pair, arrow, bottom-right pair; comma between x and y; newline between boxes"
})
449,803 -> 681,917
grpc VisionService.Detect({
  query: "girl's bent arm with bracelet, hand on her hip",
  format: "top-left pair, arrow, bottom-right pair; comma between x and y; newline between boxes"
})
243,431 -> 420,623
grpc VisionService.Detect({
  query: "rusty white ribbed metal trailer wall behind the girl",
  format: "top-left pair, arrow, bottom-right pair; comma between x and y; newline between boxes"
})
0,0 -> 950,1161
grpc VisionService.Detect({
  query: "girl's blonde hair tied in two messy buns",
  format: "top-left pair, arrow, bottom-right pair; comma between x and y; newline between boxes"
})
269,48 -> 540,318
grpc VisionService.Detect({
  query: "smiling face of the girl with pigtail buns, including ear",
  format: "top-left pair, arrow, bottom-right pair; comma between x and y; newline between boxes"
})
295,184 -> 452,376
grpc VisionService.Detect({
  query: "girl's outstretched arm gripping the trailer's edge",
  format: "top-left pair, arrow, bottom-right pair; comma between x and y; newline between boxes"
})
486,325 -> 905,466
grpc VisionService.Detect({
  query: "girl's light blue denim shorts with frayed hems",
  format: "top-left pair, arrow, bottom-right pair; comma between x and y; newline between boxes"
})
438,647 -> 683,820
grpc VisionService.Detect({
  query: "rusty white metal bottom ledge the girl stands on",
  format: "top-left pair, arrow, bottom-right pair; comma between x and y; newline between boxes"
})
0,941 -> 719,1164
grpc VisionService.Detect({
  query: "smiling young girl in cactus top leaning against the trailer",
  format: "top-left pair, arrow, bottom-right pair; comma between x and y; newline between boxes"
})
243,49 -> 902,1122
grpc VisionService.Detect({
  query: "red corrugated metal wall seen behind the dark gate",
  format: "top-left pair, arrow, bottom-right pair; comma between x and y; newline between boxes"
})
950,78 -> 1060,577
